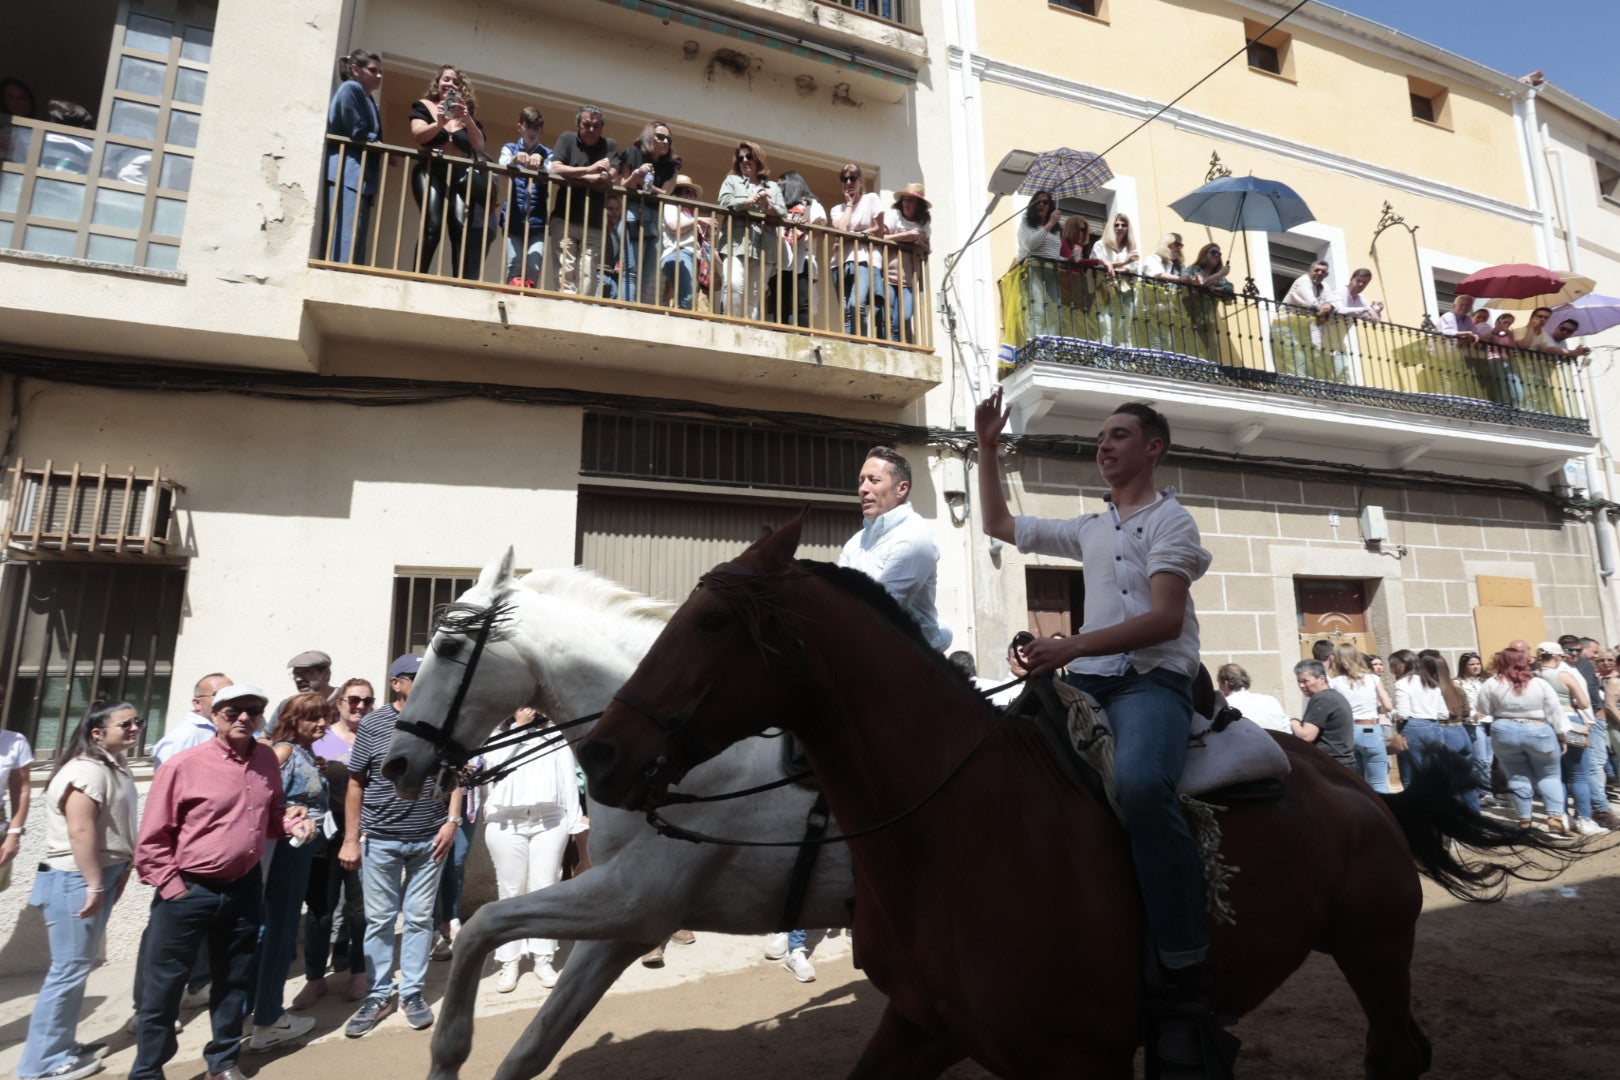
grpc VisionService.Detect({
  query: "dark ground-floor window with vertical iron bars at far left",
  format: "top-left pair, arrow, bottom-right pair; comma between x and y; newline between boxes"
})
0,560 -> 184,758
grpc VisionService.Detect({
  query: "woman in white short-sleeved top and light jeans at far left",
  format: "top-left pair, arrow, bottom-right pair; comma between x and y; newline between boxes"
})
16,701 -> 143,1080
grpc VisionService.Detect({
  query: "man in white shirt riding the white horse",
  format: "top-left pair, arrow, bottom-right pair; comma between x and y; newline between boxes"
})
838,447 -> 951,653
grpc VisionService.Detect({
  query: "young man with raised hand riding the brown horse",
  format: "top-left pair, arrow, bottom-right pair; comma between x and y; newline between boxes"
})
974,389 -> 1230,1064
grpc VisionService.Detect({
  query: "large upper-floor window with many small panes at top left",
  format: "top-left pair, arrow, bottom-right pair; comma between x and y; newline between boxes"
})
0,0 -> 214,270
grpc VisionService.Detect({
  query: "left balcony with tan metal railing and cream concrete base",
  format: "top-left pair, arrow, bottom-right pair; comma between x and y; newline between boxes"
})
308,138 -> 940,405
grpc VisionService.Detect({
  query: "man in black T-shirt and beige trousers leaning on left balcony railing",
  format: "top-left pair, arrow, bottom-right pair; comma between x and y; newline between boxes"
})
548,105 -> 619,296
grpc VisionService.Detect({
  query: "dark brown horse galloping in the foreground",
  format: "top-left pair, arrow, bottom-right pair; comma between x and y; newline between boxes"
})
578,521 -> 1568,1078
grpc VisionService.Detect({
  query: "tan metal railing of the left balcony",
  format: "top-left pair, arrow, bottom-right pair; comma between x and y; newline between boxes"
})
314,136 -> 933,351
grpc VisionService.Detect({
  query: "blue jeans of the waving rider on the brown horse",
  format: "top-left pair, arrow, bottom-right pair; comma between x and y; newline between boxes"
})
1066,667 -> 1209,968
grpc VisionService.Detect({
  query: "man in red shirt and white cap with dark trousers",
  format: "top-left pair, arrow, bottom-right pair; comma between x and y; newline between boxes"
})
130,687 -> 316,1080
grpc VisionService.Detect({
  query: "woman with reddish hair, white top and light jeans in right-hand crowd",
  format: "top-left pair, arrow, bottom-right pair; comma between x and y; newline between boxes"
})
1477,648 -> 1568,836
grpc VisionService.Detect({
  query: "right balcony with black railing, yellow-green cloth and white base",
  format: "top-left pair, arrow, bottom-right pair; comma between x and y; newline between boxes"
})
1000,259 -> 1594,483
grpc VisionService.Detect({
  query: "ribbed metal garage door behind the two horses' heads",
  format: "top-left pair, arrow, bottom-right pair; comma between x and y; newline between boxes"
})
573,489 -> 860,601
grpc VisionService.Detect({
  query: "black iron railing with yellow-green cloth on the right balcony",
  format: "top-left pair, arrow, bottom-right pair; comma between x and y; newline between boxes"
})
1000,259 -> 1588,431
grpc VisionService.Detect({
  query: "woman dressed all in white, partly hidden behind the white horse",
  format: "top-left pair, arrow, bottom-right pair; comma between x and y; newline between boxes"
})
484,709 -> 588,994
